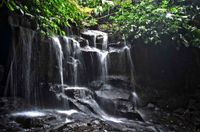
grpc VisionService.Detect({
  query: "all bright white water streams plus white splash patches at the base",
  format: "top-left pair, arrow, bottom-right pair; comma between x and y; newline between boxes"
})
6,28 -> 141,123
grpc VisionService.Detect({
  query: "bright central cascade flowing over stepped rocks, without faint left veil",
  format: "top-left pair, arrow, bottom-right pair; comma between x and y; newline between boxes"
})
50,30 -> 140,119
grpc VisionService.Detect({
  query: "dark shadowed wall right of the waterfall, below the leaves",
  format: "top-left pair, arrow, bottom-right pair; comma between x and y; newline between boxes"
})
132,40 -> 200,109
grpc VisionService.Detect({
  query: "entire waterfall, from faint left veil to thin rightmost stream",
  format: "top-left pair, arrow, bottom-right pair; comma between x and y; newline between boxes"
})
4,27 -> 142,122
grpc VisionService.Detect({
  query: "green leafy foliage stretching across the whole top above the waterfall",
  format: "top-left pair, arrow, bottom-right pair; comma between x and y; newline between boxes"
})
0,0 -> 200,47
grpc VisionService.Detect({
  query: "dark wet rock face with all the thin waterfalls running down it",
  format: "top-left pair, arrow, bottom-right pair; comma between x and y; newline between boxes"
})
2,10 -> 138,120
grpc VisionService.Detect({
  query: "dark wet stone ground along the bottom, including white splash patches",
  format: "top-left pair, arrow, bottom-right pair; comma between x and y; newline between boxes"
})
0,98 -> 199,132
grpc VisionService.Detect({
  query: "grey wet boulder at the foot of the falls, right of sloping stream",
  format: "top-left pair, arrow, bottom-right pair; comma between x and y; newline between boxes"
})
95,85 -> 143,121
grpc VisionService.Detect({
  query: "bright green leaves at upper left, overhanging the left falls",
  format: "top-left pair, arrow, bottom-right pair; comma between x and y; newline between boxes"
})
2,0 -> 86,35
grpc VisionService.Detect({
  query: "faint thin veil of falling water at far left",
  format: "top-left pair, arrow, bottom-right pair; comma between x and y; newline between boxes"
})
4,27 -> 36,103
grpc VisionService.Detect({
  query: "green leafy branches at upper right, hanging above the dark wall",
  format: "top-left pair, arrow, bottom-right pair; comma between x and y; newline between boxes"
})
110,0 -> 200,46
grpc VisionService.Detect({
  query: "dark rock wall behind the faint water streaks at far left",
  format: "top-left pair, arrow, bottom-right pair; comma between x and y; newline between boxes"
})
0,7 -> 63,107
